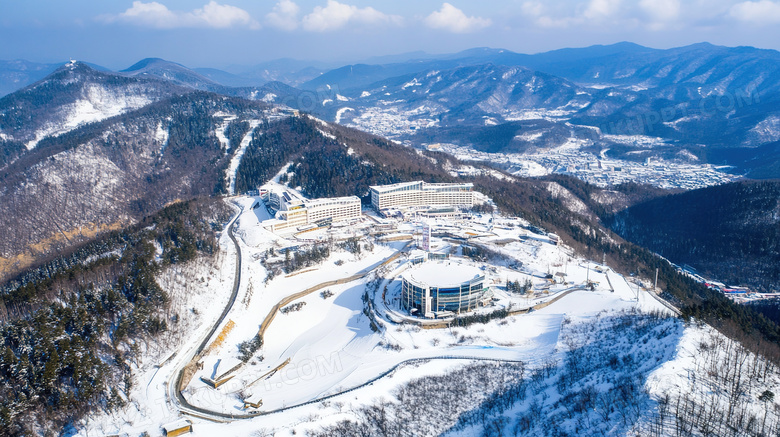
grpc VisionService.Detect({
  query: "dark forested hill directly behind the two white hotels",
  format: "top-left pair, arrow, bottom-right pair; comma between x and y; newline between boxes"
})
236,116 -> 452,198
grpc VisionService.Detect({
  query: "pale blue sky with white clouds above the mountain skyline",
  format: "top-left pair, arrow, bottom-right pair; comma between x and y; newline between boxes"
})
0,0 -> 780,69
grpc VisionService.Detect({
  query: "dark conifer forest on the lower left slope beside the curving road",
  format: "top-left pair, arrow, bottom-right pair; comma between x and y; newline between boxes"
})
0,199 -> 230,436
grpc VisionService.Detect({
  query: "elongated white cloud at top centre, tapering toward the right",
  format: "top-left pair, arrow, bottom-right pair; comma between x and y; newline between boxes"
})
302,0 -> 402,32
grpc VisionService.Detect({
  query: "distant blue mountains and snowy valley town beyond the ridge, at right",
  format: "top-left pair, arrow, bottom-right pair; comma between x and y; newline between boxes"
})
294,43 -> 780,178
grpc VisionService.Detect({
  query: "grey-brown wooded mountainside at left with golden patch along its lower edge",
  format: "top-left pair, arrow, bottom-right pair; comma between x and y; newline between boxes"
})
0,91 -> 269,276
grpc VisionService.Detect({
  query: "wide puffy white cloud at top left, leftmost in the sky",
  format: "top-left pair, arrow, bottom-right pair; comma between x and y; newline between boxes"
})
102,0 -> 260,29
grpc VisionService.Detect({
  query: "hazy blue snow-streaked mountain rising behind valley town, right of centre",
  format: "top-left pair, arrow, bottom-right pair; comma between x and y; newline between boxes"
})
318,64 -> 593,141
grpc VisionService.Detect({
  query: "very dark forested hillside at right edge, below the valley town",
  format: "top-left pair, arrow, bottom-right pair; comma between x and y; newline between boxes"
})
608,181 -> 780,292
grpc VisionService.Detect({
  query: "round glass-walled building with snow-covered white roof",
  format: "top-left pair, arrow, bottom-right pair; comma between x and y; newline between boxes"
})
401,261 -> 493,318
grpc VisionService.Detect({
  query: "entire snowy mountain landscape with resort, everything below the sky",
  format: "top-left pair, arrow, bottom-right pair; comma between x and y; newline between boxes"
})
0,35 -> 780,436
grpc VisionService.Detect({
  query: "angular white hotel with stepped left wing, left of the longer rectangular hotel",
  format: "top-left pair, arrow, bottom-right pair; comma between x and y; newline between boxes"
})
263,190 -> 361,232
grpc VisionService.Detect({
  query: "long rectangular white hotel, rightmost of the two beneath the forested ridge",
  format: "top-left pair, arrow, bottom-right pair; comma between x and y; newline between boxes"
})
370,181 -> 474,210
